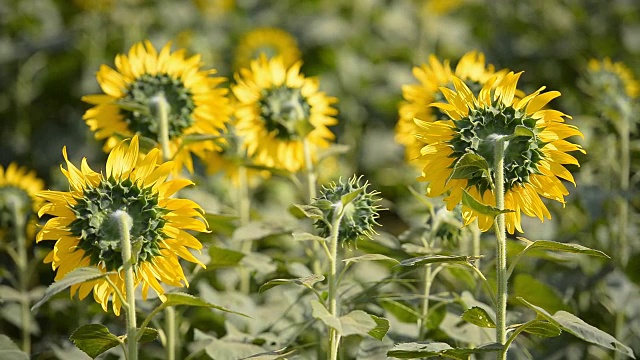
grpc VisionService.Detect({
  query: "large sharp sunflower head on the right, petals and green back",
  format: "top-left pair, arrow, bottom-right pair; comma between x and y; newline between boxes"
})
416,72 -> 584,234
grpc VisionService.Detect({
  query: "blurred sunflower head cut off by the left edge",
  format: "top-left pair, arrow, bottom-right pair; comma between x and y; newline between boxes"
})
0,163 -> 44,239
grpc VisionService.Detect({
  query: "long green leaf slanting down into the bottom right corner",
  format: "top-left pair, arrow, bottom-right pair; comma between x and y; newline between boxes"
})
518,297 -> 636,359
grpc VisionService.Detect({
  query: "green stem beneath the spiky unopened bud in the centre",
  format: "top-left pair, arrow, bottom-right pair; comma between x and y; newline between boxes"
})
327,203 -> 344,360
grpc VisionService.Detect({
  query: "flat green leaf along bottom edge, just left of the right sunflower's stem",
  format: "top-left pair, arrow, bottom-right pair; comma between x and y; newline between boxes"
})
387,342 -> 502,360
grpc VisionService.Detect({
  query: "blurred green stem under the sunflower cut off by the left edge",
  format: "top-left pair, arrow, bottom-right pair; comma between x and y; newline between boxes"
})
9,201 -> 31,354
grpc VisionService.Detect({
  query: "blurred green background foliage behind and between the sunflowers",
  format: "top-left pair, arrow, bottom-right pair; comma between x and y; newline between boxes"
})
0,0 -> 640,359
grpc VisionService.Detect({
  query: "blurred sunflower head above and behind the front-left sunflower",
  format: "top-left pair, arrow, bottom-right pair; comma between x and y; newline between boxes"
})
82,41 -> 231,172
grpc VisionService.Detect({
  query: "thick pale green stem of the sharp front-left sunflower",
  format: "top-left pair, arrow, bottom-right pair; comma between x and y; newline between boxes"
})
112,210 -> 138,360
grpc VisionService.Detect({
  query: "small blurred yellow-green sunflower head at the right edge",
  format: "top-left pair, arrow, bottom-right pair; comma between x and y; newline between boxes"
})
589,58 -> 640,99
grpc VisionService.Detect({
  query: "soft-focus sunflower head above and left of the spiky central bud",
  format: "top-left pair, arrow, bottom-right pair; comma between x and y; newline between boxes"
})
231,55 -> 338,172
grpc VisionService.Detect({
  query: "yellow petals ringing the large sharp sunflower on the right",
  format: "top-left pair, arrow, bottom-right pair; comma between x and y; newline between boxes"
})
416,72 -> 584,234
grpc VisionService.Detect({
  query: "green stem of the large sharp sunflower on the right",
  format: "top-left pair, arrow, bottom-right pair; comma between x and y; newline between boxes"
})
494,139 -> 508,359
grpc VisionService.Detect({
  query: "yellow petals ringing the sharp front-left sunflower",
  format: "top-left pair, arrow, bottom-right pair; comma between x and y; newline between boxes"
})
36,136 -> 207,315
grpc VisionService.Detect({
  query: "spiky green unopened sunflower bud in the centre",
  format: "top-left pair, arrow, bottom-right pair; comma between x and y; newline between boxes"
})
311,176 -> 381,244
